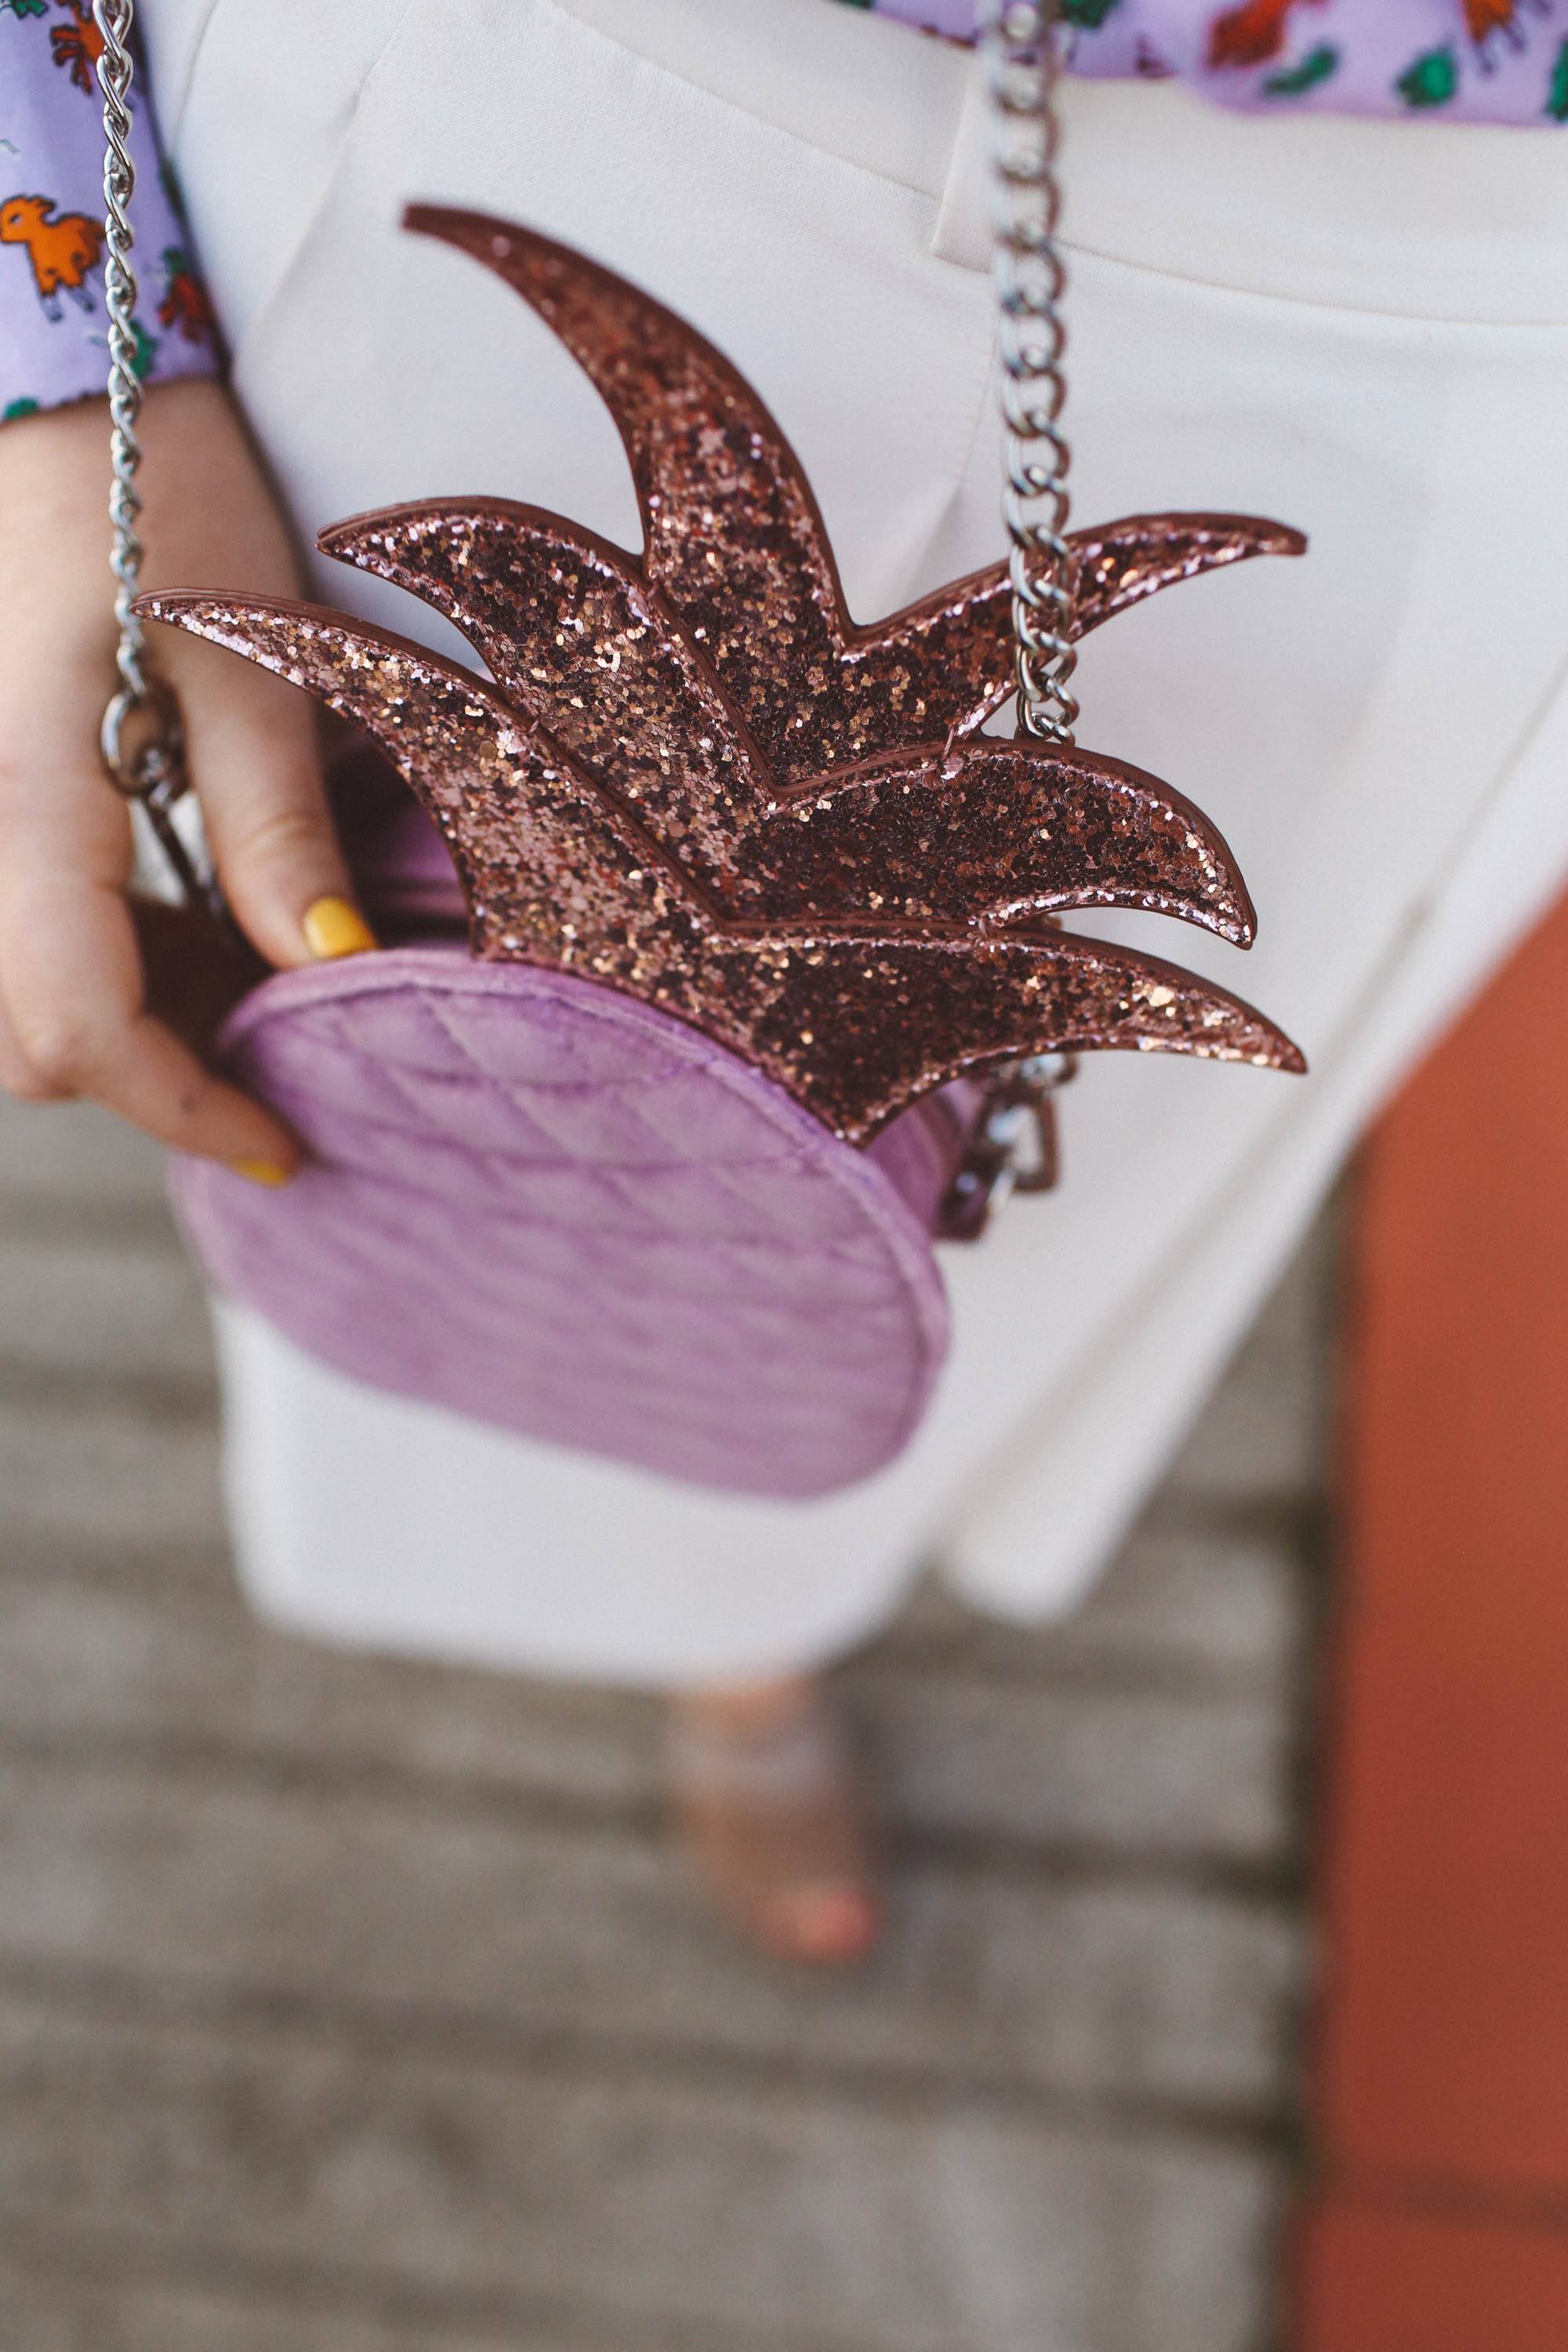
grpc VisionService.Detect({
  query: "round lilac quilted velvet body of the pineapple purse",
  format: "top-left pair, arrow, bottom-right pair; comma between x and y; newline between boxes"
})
176,946 -> 956,1498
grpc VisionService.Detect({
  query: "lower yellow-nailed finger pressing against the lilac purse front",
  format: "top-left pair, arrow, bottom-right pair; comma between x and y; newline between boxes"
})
0,868 -> 301,1183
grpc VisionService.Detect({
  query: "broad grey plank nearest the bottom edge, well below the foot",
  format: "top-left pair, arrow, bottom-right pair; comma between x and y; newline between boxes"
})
0,1994 -> 1279,2352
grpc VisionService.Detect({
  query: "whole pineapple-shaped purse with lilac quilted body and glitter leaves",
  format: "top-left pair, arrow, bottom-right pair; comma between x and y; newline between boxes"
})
98,4 -> 1300,1496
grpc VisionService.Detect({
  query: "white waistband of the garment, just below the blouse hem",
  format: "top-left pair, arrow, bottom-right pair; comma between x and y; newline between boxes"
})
555,0 -> 1568,325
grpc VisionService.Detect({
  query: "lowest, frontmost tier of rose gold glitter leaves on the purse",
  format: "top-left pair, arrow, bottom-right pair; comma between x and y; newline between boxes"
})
141,590 -> 1300,1143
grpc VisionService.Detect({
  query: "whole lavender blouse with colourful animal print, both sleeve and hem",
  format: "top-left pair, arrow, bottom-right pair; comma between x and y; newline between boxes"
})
0,0 -> 1568,421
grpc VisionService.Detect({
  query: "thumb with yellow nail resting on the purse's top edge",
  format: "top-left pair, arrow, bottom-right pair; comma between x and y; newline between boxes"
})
160,630 -> 376,967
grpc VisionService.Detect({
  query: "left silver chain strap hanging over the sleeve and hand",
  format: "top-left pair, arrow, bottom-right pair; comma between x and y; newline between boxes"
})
92,0 -> 216,913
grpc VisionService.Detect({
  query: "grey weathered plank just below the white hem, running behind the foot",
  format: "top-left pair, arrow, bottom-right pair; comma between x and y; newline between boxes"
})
0,1576 -> 1295,1870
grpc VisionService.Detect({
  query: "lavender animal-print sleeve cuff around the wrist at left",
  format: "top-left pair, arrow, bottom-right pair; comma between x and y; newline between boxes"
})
0,0 -> 214,421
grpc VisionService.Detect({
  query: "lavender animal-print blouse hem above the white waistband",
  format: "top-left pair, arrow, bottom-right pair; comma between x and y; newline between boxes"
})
846,0 -> 1568,125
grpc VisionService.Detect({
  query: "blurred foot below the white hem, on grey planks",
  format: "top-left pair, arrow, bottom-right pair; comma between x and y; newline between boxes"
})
668,1679 -> 881,1966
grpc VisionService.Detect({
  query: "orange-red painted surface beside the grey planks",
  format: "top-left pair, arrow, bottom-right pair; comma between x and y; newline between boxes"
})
1298,889 -> 1568,2352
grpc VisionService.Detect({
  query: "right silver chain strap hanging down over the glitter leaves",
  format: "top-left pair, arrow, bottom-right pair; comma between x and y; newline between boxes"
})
980,0 -> 1079,743
